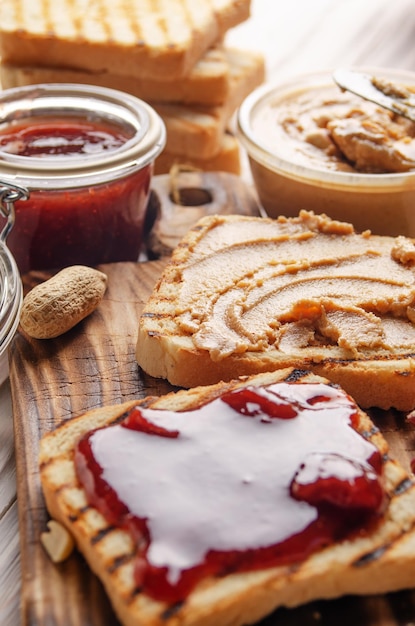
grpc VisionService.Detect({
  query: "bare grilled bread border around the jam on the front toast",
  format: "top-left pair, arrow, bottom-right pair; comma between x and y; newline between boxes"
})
40,370 -> 415,626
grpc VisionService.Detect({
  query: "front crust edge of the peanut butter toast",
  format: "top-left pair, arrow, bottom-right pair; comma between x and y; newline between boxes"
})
137,326 -> 415,411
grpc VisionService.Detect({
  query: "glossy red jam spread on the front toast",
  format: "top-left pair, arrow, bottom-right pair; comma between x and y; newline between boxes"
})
75,383 -> 385,603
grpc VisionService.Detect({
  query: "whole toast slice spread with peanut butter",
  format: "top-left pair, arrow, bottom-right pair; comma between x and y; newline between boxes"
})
136,211 -> 415,411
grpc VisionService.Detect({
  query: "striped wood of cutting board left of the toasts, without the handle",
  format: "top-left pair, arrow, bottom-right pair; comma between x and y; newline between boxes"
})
10,261 -> 171,626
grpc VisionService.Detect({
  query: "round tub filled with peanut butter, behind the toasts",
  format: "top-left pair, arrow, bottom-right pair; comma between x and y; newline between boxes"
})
237,68 -> 415,237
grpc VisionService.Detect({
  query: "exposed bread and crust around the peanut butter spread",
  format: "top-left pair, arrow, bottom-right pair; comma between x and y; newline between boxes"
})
136,216 -> 415,411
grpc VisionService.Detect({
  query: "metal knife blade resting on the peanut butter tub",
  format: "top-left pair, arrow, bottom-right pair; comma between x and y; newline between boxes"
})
333,69 -> 415,122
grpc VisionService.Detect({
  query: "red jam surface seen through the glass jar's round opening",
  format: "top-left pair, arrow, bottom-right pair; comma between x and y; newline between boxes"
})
0,118 -> 129,158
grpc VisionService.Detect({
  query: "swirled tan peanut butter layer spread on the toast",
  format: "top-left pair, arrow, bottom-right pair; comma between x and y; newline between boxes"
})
172,211 -> 415,361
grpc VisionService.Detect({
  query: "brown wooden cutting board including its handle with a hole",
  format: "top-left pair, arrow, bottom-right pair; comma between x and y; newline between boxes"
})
9,172 -> 260,626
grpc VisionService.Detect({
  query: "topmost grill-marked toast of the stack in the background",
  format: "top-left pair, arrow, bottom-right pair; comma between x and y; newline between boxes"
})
0,0 -> 250,80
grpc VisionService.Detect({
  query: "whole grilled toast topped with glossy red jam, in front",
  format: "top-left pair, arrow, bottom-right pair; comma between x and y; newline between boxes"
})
40,369 -> 415,626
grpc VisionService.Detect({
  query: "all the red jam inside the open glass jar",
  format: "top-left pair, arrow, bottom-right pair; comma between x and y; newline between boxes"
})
0,117 -> 152,274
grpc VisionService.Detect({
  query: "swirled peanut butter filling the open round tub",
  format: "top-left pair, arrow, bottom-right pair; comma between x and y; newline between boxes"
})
252,86 -> 415,174
